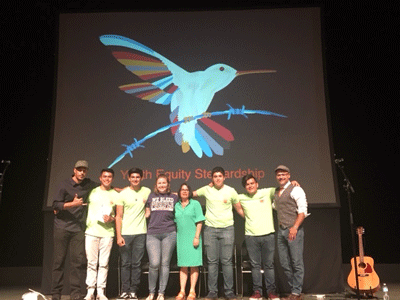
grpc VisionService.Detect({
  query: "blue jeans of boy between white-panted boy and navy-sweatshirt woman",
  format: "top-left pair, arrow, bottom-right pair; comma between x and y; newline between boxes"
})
119,234 -> 146,293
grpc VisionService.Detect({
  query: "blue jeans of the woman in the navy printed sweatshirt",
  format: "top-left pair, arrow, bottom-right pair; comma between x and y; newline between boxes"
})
146,231 -> 176,294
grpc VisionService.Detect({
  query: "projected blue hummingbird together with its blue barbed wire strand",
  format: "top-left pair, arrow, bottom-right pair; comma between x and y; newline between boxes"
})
100,35 -> 285,167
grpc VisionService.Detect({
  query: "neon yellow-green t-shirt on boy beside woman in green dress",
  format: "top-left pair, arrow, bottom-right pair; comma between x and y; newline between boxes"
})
197,184 -> 239,228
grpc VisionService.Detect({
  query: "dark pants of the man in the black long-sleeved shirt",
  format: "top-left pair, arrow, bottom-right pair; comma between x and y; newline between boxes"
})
51,228 -> 86,299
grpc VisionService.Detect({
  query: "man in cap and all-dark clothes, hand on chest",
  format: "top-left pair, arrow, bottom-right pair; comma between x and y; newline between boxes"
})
51,160 -> 99,300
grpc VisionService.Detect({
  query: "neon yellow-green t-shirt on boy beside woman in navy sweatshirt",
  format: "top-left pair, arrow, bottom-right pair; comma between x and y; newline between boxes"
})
116,186 -> 151,235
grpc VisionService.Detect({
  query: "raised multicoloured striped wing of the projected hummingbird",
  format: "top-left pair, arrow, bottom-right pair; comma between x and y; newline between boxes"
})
100,35 -> 187,105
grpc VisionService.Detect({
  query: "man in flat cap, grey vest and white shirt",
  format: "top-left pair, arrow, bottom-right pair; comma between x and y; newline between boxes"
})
274,165 -> 309,300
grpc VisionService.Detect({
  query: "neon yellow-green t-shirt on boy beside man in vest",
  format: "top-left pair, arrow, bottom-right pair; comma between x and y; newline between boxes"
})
238,188 -> 275,236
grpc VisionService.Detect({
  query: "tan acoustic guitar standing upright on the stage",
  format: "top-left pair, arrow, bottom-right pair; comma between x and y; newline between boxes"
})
347,227 -> 380,294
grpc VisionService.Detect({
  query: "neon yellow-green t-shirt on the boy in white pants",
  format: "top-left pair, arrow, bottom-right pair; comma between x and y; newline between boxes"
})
85,187 -> 118,237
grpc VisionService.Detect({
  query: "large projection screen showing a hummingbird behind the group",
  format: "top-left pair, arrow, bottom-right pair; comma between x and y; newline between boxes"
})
44,7 -> 338,207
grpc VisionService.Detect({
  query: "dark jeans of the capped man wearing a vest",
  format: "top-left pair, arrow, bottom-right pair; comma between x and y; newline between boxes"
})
277,227 -> 304,294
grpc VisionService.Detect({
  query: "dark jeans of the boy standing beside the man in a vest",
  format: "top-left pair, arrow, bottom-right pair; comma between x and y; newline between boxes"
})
245,233 -> 276,295
